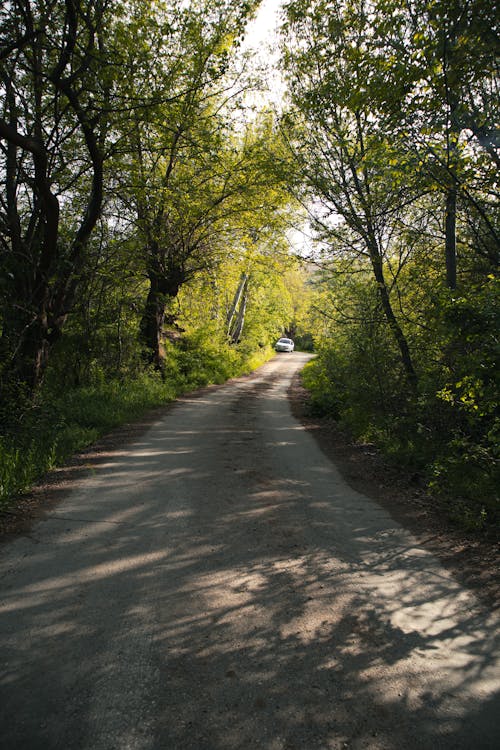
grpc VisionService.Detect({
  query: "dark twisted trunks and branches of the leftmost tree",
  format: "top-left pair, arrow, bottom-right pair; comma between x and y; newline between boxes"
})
0,2 -> 106,391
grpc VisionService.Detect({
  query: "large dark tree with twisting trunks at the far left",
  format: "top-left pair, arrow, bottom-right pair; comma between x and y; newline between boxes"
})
0,0 -> 112,390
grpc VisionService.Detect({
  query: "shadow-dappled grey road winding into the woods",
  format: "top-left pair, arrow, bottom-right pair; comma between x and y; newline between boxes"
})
0,353 -> 500,750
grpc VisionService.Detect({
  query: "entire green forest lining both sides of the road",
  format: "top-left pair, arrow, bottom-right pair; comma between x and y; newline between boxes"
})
0,0 -> 500,533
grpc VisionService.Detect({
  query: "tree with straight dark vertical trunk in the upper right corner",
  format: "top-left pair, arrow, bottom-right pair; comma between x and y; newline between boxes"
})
371,0 -> 499,289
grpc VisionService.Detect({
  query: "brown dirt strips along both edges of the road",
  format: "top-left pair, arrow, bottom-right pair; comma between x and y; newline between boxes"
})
0,374 -> 500,607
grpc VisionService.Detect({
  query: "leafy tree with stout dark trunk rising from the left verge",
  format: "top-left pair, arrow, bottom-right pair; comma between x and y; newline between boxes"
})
111,0 -> 264,370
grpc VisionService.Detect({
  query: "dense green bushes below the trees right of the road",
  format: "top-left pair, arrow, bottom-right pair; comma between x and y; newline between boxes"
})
303,273 -> 500,530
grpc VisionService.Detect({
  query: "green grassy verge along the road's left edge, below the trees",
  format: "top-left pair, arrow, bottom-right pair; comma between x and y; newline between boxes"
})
0,342 -> 273,510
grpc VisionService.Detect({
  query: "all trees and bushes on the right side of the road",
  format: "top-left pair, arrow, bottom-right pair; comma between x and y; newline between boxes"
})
283,0 -> 500,531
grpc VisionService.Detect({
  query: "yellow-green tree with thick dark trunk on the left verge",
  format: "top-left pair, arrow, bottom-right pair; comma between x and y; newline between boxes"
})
115,10 -> 298,370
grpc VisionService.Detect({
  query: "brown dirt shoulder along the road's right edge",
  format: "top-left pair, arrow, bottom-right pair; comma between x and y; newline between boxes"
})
288,373 -> 500,608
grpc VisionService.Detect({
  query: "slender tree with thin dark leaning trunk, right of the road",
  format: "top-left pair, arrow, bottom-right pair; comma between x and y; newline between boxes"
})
283,0 -> 417,387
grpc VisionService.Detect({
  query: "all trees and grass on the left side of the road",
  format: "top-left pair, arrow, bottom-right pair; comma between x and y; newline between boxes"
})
0,0 -> 310,507
